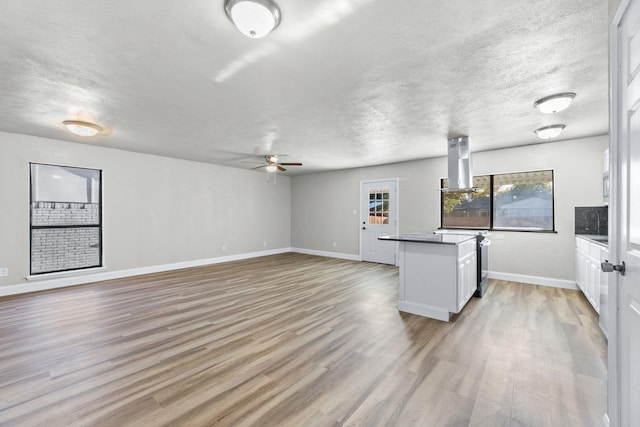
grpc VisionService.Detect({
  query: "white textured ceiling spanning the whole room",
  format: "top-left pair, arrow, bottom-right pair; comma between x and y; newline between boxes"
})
0,0 -> 608,174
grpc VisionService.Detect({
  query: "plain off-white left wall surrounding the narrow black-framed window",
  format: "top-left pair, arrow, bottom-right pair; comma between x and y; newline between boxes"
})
0,132 -> 291,287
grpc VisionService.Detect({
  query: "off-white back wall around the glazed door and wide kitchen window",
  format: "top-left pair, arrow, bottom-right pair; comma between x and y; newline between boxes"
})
291,135 -> 608,281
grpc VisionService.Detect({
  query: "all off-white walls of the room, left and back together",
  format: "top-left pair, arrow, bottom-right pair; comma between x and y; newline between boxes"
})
0,132 -> 608,286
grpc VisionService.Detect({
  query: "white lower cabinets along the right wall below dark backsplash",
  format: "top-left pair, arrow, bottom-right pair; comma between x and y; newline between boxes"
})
575,236 -> 609,313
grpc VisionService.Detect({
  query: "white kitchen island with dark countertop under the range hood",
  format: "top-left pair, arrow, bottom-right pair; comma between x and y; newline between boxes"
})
378,232 -> 477,322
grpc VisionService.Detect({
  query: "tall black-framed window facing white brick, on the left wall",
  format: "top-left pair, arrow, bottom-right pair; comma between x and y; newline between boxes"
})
31,163 -> 102,274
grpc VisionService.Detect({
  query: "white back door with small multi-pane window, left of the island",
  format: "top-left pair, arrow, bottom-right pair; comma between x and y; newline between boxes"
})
360,180 -> 398,265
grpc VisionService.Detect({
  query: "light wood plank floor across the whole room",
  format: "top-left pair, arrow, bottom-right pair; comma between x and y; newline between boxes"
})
0,254 -> 606,427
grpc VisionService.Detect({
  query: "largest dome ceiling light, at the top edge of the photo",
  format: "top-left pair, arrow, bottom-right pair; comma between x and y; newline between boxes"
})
224,0 -> 280,39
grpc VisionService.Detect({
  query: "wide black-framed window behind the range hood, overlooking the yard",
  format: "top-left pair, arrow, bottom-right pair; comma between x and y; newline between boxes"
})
440,170 -> 555,231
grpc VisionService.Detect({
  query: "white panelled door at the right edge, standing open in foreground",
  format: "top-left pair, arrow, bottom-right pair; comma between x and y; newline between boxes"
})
609,0 -> 640,426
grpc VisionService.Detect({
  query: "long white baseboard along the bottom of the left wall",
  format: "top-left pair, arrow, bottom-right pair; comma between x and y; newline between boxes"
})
0,248 -> 292,297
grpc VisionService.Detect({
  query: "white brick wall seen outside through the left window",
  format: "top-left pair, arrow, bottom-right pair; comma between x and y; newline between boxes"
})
31,202 -> 101,274
